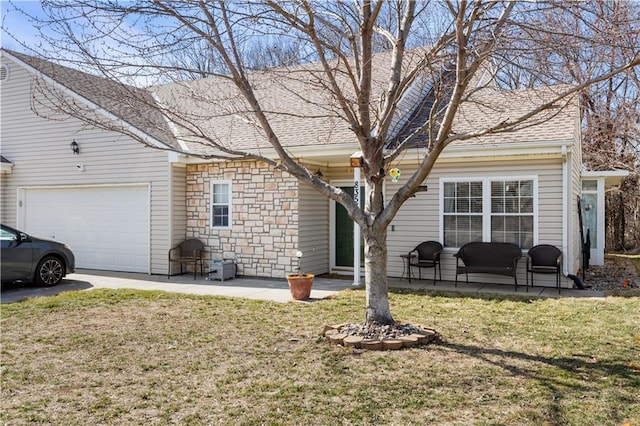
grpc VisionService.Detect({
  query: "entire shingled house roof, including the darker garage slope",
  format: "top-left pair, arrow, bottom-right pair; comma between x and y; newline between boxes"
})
5,49 -> 578,156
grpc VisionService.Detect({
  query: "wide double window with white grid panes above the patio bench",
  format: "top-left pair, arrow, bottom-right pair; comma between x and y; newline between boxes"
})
441,178 -> 537,249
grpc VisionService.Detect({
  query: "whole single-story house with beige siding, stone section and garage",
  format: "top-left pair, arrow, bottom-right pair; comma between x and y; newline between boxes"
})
0,51 -> 624,286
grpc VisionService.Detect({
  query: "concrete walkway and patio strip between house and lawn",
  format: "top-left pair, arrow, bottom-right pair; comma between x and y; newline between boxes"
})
1,270 -> 605,303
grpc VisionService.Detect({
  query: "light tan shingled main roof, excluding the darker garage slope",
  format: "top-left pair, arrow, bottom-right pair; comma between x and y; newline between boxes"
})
153,53 -> 578,155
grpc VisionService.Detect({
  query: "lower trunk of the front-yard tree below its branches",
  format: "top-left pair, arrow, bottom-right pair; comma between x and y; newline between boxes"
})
363,227 -> 394,324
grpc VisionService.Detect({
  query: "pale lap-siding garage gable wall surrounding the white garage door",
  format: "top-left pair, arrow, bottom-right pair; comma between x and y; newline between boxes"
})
0,58 -> 171,274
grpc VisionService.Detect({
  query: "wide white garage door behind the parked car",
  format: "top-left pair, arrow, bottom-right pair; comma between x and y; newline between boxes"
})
22,185 -> 149,272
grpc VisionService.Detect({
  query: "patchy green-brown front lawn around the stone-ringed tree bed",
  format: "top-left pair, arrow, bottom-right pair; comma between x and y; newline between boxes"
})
0,290 -> 640,426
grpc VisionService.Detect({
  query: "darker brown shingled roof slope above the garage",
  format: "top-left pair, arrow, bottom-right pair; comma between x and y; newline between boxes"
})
2,49 -> 177,147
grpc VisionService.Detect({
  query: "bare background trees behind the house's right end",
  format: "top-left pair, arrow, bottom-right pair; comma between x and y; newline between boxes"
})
490,0 -> 640,250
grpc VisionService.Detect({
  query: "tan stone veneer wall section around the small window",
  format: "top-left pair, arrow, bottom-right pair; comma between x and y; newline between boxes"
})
187,161 -> 299,278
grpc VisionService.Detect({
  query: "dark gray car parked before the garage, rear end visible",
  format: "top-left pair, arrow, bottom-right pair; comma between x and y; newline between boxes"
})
0,225 -> 76,286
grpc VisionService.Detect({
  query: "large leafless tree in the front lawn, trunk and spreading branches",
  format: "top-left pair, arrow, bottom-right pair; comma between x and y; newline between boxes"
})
10,0 -> 640,324
